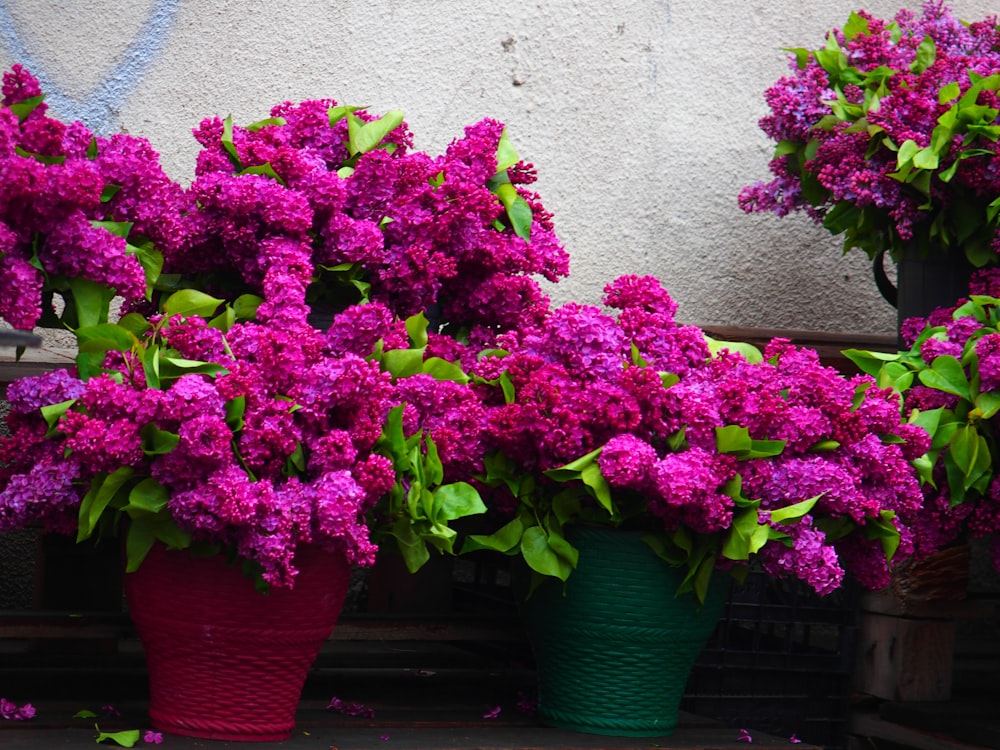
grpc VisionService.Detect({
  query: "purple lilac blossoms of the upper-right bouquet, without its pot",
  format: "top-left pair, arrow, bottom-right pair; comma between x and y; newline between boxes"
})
739,1 -> 1000,253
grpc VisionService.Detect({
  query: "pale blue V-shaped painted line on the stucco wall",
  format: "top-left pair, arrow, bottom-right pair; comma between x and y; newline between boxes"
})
0,0 -> 180,135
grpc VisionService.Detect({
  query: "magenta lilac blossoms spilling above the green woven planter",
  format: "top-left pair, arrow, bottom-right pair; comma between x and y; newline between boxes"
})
480,276 -> 930,594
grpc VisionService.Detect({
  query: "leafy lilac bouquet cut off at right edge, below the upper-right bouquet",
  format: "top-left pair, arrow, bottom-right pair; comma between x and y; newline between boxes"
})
844,269 -> 1000,606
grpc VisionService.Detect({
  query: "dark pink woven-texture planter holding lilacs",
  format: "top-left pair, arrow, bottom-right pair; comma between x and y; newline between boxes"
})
125,545 -> 350,742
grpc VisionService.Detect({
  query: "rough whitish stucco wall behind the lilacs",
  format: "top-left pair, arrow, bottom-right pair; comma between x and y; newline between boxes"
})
0,0 -> 993,334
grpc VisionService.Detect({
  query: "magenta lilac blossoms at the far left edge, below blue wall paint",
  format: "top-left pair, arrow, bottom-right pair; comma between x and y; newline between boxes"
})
0,65 -> 184,330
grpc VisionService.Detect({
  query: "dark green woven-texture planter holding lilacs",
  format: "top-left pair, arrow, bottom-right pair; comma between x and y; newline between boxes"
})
521,527 -> 728,737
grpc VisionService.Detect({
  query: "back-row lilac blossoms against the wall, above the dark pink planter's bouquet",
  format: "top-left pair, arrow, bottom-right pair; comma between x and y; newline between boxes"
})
180,99 -> 568,329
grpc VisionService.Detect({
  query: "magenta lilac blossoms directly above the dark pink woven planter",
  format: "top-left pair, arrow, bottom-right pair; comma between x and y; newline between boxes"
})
0,318 -> 394,585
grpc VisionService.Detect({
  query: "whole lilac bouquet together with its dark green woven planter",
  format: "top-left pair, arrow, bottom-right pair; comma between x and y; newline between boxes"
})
464,277 -> 929,735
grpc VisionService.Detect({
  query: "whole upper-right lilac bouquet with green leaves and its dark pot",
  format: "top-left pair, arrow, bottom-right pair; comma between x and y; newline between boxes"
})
739,0 -> 1000,322
